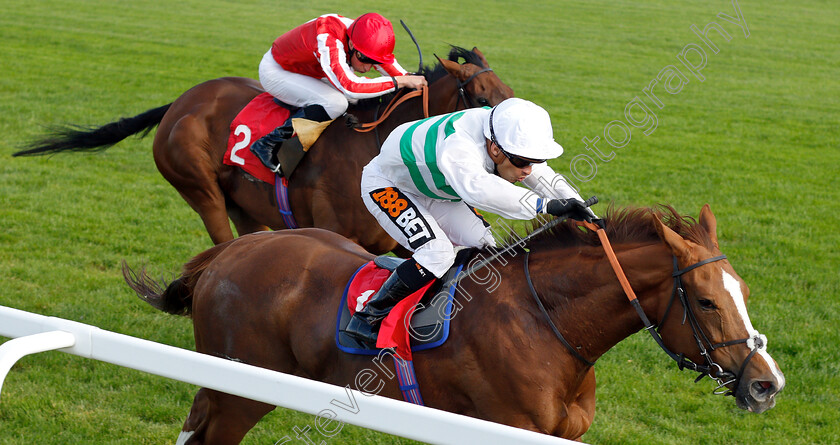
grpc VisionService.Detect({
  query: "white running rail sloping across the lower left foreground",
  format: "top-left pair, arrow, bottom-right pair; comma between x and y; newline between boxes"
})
0,306 -> 579,445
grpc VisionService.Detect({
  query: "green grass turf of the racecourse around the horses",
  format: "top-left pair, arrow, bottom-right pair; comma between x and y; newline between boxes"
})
0,0 -> 840,444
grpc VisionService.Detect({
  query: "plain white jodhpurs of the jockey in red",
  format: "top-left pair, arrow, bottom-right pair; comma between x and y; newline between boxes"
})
260,50 -> 348,119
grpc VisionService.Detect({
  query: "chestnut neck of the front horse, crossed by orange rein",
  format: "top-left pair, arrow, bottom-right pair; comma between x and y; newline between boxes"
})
532,243 -> 673,362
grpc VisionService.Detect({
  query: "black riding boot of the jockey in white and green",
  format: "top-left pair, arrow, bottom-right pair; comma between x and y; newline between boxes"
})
344,272 -> 419,348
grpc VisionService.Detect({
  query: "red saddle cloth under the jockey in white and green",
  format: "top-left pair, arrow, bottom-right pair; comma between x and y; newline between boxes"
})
347,261 -> 434,360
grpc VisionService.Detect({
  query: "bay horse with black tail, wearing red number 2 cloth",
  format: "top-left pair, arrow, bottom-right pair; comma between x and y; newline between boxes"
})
15,47 -> 513,253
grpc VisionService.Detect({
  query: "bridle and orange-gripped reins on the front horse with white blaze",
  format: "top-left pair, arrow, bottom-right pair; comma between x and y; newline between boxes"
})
524,222 -> 767,396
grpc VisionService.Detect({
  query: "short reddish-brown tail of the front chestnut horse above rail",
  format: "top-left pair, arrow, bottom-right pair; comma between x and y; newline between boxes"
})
122,241 -> 231,316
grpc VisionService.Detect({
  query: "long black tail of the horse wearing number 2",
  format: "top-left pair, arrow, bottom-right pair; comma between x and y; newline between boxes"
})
12,103 -> 172,156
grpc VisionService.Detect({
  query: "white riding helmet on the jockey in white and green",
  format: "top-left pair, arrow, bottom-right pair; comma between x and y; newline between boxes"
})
484,97 -> 563,160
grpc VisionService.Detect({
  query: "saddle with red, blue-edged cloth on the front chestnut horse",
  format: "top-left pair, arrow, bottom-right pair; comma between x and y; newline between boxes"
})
335,249 -> 475,360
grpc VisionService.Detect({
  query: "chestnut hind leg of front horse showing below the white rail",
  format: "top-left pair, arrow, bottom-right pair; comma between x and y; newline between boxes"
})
177,388 -> 274,445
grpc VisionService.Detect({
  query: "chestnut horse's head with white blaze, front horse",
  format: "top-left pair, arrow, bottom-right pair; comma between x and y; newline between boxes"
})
655,205 -> 785,413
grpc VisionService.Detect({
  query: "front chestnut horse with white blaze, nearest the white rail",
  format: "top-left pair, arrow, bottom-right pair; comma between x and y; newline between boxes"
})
123,206 -> 785,444
